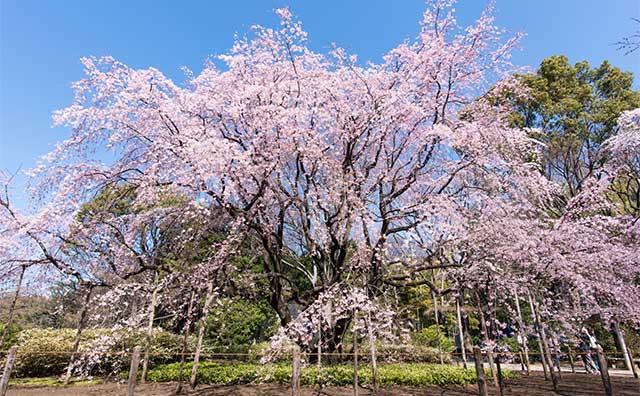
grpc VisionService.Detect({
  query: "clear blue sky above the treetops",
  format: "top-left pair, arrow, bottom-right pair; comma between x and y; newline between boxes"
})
0,0 -> 640,186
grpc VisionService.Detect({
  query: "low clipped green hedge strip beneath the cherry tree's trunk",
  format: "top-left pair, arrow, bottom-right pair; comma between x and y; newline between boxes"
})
147,362 -> 515,386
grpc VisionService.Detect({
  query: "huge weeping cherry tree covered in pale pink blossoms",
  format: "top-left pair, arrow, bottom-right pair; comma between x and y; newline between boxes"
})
0,1 -> 638,385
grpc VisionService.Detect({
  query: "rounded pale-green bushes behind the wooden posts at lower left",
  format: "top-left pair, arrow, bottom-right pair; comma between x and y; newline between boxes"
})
15,329 -> 188,377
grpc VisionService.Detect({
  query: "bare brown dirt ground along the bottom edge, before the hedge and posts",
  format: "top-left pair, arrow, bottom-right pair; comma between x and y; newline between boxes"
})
7,373 -> 640,396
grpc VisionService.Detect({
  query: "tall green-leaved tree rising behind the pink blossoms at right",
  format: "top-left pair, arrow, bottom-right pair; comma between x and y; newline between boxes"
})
514,55 -> 640,198
